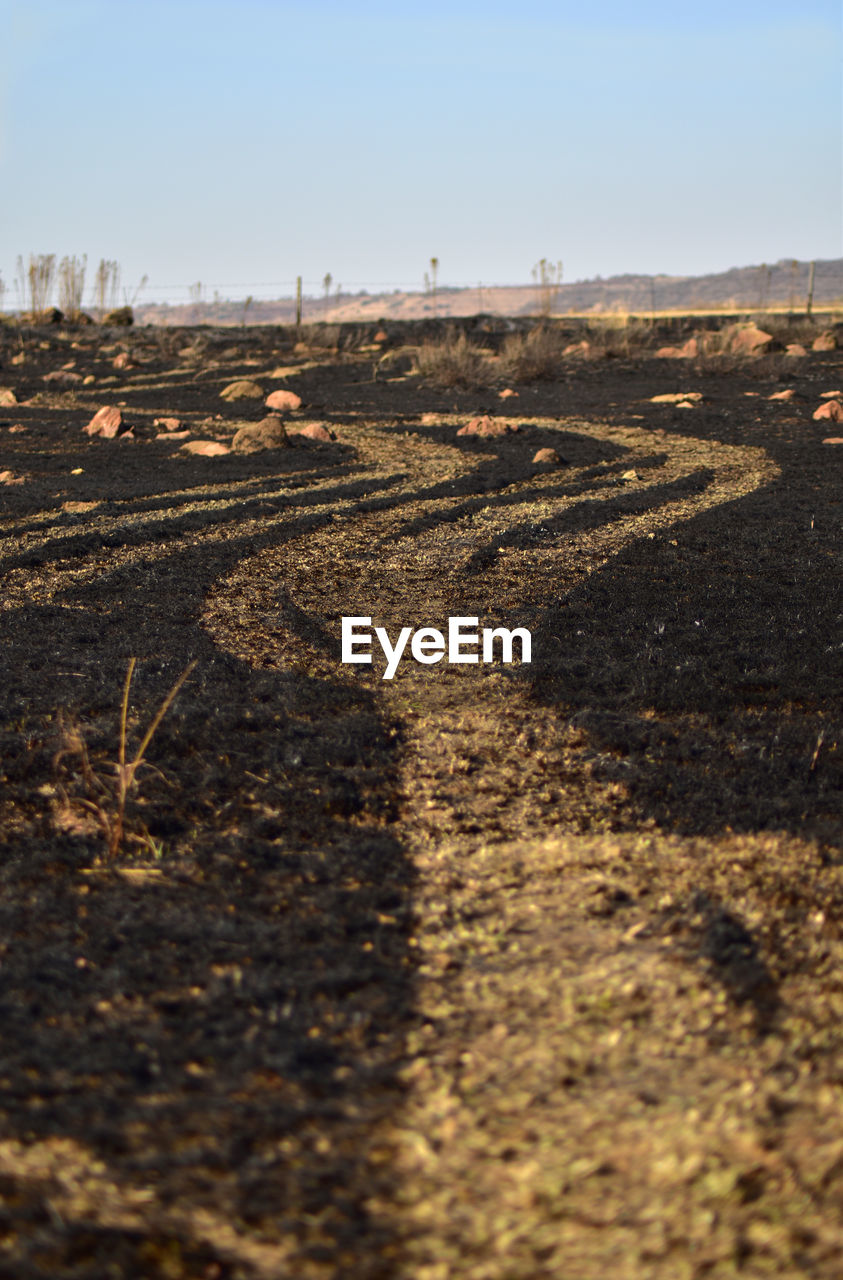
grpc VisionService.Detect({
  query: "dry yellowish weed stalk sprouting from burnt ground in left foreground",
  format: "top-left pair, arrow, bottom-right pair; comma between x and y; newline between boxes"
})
52,658 -> 196,858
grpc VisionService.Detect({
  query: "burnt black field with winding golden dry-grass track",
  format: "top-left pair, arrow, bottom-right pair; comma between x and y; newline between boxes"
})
0,312 -> 843,1280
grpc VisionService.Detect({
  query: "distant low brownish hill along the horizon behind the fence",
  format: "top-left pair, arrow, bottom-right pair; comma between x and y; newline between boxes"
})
136,257 -> 843,325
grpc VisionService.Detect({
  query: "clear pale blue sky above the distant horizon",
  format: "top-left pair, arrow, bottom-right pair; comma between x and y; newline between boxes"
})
0,0 -> 843,306
